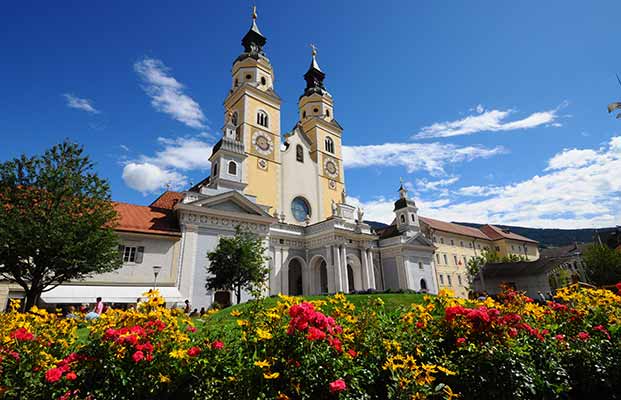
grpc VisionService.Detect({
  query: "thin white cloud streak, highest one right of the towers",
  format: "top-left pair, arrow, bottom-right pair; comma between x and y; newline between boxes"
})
413,103 -> 566,139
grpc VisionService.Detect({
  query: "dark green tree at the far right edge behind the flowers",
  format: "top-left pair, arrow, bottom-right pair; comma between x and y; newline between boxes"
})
582,244 -> 621,286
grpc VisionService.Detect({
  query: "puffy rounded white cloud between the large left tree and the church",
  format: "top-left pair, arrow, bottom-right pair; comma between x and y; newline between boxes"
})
123,162 -> 187,195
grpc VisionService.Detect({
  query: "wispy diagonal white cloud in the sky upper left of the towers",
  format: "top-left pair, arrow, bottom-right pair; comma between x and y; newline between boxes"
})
134,58 -> 205,129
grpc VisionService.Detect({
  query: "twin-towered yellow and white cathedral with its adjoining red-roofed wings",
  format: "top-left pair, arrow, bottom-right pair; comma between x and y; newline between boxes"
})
0,8 -> 537,308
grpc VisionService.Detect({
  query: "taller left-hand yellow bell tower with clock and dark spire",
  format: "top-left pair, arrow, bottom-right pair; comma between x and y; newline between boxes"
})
224,7 -> 281,213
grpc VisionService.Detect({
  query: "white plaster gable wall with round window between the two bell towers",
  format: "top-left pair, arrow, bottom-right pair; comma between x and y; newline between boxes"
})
279,133 -> 320,225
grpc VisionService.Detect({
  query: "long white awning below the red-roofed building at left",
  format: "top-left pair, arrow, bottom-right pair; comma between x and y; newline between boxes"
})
41,285 -> 183,304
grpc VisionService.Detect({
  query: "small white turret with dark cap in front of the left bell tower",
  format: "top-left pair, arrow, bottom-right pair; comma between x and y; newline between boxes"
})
209,111 -> 246,191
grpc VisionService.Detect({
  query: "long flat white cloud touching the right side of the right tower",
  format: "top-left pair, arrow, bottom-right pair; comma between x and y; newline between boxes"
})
343,143 -> 506,175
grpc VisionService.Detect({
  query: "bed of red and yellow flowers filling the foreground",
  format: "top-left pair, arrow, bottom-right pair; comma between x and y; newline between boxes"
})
0,287 -> 621,400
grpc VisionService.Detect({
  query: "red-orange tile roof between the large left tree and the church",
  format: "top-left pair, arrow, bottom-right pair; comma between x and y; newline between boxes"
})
113,199 -> 181,236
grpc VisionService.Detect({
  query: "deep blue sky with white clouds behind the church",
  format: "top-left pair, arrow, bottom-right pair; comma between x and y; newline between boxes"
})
0,0 -> 621,228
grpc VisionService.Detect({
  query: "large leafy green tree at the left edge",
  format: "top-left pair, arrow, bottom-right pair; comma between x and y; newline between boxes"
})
0,141 -> 121,310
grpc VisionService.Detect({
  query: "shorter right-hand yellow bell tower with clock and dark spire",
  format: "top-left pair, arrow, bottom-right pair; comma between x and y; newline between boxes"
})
298,45 -> 345,219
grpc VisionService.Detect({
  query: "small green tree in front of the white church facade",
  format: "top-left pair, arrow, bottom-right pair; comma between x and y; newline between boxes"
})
205,226 -> 269,304
